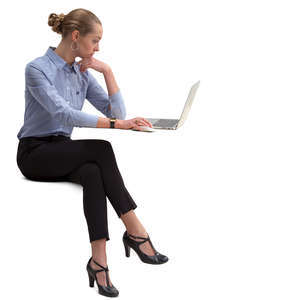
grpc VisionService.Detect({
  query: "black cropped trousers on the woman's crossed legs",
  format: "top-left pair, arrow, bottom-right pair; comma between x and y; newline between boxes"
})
17,135 -> 137,242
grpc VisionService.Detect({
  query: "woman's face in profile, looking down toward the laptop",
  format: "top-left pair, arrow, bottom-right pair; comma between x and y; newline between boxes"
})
73,24 -> 103,58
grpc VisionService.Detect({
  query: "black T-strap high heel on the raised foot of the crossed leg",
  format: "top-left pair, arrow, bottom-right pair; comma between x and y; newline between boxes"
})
123,230 -> 169,265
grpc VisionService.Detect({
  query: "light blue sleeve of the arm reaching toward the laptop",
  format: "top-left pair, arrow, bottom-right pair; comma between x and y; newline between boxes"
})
25,64 -> 99,128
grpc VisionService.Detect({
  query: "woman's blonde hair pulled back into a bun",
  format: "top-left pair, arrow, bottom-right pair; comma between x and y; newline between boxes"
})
48,8 -> 102,39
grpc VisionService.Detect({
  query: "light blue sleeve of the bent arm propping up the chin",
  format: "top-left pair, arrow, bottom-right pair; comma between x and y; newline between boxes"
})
86,71 -> 126,120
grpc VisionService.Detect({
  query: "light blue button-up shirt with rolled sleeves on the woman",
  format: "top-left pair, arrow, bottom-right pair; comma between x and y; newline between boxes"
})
17,46 -> 126,139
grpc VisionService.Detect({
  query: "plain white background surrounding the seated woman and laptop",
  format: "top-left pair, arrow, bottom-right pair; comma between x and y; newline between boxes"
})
0,0 -> 300,300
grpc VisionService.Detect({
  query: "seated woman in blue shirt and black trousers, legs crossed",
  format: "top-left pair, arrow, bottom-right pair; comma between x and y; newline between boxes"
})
17,9 -> 168,296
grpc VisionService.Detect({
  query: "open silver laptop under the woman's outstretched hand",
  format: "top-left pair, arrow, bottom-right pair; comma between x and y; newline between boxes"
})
146,80 -> 200,130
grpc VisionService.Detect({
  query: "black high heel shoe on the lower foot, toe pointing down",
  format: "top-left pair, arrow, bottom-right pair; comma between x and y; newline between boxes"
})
86,257 -> 119,297
